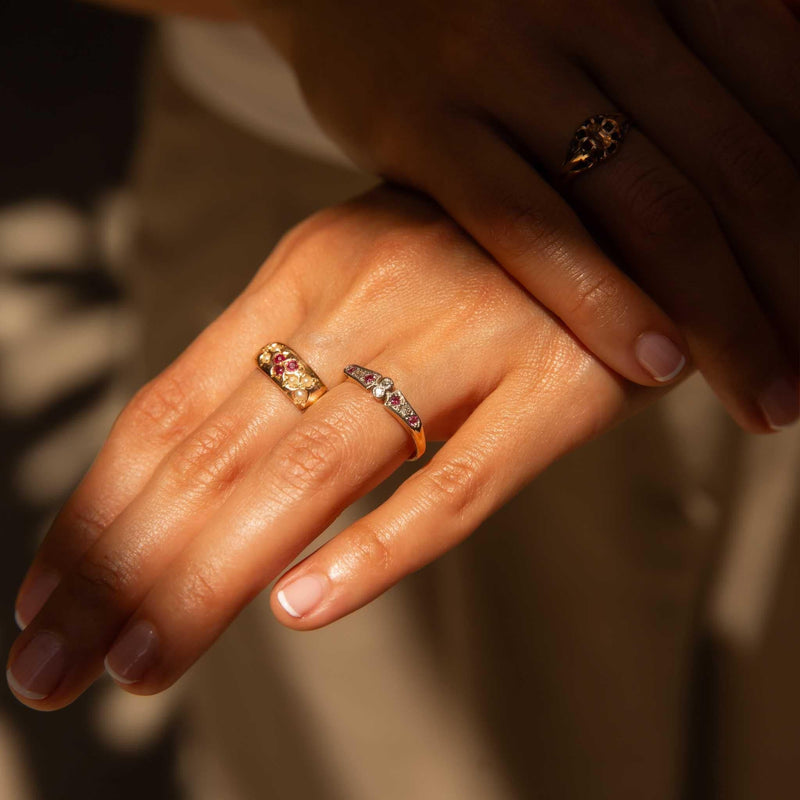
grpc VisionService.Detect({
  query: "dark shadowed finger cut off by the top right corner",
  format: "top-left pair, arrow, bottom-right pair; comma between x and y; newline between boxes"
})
666,0 -> 800,167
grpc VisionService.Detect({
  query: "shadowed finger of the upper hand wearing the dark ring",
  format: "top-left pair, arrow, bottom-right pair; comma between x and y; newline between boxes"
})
482,57 -> 796,432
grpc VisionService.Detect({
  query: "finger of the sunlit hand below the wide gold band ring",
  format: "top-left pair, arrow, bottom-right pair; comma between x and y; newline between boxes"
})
10,356 -> 316,704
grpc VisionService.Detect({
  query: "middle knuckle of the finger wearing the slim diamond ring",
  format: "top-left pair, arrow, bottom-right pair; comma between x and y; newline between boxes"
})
275,420 -> 347,497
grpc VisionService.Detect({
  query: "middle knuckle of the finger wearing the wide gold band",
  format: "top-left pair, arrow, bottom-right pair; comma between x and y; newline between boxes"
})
169,417 -> 247,491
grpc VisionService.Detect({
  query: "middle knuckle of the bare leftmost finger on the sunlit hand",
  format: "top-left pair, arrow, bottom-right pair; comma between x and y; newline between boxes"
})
120,371 -> 197,444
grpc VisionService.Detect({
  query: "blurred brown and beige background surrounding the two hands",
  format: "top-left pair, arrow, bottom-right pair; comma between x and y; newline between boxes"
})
0,0 -> 800,800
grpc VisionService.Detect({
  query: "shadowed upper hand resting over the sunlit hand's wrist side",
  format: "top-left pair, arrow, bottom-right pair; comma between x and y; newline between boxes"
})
241,0 -> 800,432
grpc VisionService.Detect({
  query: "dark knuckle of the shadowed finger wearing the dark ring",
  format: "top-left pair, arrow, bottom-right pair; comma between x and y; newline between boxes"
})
626,166 -> 715,242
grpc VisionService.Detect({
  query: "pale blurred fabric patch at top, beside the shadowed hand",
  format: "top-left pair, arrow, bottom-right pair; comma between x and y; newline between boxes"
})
162,17 -> 352,166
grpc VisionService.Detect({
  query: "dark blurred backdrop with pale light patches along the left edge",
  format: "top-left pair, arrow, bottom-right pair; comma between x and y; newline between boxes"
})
0,0 -> 182,800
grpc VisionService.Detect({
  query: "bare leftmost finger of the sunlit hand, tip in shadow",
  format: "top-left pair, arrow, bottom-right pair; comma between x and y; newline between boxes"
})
15,278 -> 306,628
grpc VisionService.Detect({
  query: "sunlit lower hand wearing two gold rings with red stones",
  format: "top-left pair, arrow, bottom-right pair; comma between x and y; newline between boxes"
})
8,189 -> 659,710
